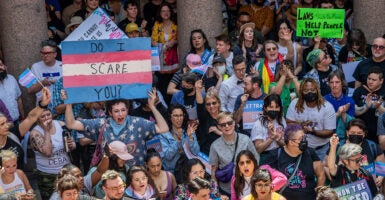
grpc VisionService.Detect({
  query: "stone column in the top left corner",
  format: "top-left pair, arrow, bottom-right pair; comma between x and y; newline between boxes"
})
0,0 -> 48,112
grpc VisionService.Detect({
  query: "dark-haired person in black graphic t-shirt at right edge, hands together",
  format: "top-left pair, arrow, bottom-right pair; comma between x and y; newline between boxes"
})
353,66 -> 385,142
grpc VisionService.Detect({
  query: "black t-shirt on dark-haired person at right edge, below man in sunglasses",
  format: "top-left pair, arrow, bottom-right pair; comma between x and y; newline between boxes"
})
353,86 -> 385,143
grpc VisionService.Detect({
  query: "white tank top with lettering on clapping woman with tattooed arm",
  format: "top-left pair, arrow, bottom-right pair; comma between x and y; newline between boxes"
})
33,120 -> 70,174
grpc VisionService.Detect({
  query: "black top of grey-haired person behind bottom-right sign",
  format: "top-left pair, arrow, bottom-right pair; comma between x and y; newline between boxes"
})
328,165 -> 378,197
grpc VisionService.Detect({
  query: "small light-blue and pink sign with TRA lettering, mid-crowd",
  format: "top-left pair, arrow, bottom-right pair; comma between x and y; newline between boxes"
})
242,100 -> 263,129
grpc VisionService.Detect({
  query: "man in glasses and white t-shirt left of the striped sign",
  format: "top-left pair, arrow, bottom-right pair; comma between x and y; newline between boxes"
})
27,40 -> 62,104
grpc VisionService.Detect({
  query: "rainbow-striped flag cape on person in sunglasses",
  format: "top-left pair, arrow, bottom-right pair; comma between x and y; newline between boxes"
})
258,53 -> 283,94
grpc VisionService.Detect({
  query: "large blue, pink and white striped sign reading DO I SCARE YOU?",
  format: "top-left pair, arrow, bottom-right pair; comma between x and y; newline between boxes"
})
62,38 -> 152,103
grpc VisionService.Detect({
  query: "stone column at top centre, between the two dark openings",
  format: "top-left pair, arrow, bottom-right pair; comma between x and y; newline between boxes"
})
177,0 -> 222,61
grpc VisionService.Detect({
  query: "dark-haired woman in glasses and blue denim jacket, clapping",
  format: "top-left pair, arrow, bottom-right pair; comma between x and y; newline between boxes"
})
159,104 -> 199,173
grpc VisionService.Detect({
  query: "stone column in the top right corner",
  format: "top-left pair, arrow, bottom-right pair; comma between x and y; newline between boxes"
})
353,0 -> 385,44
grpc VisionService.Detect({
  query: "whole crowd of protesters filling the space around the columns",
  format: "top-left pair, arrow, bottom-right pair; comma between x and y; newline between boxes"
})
0,0 -> 385,200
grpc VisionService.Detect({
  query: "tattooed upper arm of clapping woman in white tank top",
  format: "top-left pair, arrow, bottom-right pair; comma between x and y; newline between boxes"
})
30,130 -> 52,157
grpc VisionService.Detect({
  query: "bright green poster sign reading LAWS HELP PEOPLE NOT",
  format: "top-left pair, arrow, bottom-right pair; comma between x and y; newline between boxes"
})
297,8 -> 345,38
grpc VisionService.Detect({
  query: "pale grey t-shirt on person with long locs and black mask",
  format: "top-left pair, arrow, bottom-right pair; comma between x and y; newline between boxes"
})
286,98 -> 337,148
